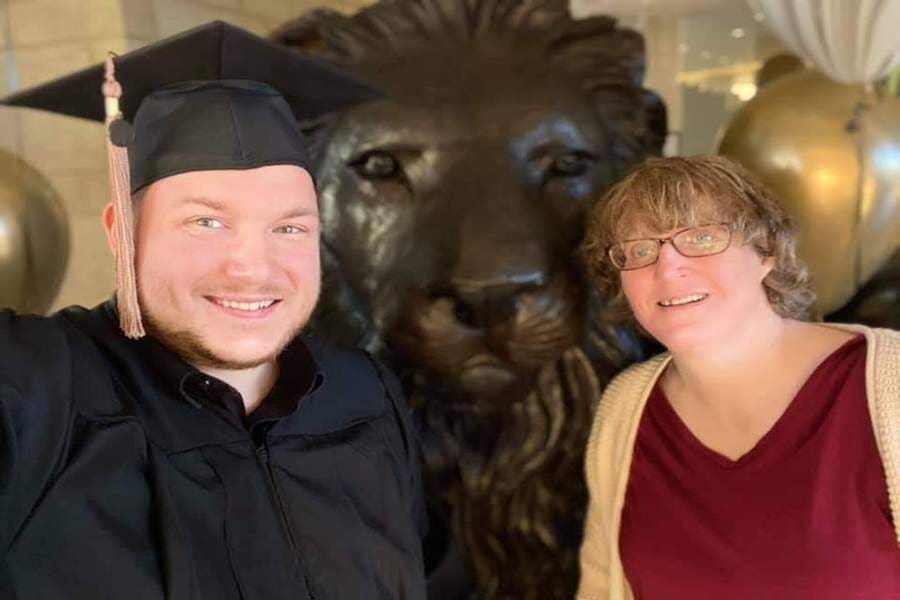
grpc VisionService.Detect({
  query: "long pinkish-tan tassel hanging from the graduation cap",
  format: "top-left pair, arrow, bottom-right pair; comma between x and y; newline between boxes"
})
103,53 -> 145,339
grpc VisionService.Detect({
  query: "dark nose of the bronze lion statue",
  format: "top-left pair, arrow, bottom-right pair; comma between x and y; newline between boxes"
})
439,273 -> 546,329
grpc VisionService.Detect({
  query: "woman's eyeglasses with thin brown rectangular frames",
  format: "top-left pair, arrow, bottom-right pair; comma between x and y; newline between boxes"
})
607,224 -> 731,271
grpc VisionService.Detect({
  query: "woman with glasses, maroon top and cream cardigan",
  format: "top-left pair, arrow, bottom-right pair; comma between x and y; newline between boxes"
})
578,157 -> 900,600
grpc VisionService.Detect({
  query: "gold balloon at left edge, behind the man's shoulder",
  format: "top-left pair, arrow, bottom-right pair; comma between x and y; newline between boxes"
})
0,150 -> 69,313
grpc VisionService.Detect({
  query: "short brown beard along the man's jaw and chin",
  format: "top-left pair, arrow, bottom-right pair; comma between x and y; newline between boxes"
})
141,310 -> 308,371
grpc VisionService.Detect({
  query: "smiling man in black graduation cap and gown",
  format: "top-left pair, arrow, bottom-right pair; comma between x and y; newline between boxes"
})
0,23 -> 425,600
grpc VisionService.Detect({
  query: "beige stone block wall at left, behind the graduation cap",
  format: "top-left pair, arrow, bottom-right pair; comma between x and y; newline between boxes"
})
0,0 -> 368,316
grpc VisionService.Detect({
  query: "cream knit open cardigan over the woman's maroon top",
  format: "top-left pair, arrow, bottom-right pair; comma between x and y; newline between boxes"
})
578,324 -> 900,600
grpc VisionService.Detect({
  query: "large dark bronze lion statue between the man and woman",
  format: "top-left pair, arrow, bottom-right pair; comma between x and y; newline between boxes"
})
273,0 -> 666,600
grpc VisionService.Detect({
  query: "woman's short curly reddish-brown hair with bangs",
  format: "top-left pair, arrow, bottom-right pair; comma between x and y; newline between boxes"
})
582,156 -> 815,319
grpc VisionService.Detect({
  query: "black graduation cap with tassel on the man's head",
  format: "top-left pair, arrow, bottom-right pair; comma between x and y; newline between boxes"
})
0,21 -> 380,338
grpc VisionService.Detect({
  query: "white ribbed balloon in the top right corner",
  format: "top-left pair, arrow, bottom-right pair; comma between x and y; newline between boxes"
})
748,0 -> 900,83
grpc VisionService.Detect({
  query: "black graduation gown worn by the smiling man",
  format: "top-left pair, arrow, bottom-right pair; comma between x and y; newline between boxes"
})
0,303 -> 425,600
